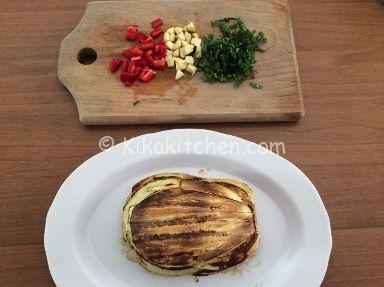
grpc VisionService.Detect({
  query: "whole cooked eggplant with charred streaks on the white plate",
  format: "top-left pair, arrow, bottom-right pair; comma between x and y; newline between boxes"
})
123,173 -> 259,275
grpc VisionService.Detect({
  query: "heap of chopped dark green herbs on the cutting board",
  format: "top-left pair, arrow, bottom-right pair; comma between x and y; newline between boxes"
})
197,18 -> 267,87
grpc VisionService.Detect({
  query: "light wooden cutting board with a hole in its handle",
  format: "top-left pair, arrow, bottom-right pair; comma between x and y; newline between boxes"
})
58,0 -> 304,125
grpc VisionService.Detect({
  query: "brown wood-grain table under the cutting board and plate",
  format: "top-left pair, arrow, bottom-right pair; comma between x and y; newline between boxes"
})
0,0 -> 384,287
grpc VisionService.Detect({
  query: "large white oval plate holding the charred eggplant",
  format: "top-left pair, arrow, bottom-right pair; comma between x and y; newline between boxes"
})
44,129 -> 332,287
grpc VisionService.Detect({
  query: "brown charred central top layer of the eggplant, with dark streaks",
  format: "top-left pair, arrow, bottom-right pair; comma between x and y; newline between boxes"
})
131,189 -> 255,265
